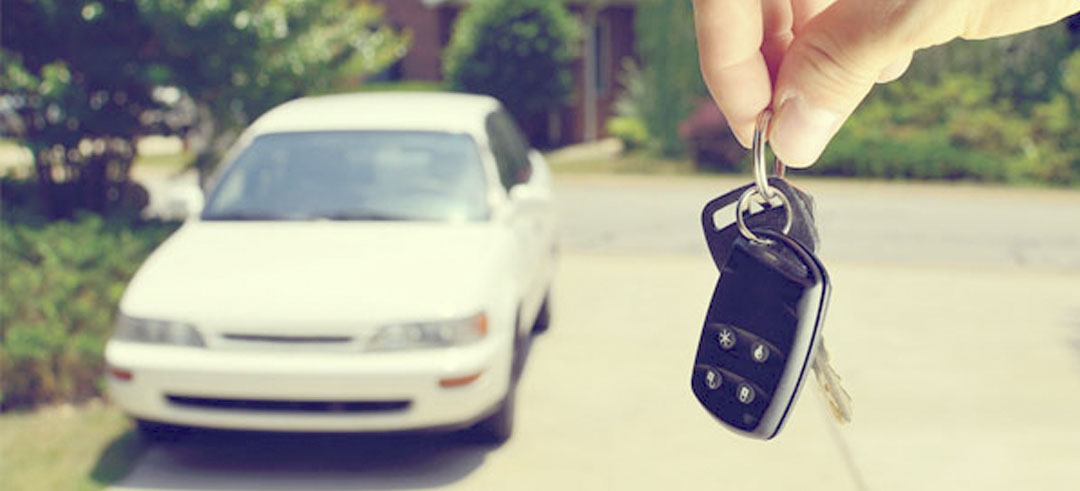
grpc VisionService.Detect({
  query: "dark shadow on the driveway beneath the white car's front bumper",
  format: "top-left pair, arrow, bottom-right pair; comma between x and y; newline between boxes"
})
94,431 -> 496,490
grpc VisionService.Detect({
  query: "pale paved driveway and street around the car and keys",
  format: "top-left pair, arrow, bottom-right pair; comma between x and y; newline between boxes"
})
113,177 -> 1080,490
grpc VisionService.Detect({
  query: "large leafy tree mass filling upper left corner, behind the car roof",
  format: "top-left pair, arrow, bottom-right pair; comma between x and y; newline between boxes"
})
0,0 -> 408,217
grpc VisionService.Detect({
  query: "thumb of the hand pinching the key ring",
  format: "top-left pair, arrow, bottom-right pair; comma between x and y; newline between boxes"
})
769,0 -> 963,167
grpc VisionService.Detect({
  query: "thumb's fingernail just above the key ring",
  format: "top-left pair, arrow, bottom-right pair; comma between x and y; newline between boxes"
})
769,95 -> 841,167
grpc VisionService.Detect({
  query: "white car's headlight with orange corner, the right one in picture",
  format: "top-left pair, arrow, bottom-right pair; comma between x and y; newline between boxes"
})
368,313 -> 487,351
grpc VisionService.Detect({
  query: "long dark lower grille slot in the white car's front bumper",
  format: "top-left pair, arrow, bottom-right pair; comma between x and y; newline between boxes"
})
165,395 -> 410,413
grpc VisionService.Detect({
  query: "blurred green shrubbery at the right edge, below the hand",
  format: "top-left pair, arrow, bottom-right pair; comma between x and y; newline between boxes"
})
809,24 -> 1080,185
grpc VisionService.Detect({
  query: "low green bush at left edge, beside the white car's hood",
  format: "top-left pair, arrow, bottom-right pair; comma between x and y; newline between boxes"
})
0,214 -> 176,410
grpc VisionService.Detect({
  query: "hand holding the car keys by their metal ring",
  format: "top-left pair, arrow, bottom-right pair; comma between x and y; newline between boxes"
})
693,0 -> 1080,167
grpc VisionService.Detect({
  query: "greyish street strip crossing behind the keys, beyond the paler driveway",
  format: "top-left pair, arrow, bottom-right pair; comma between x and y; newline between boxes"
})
558,176 -> 1080,272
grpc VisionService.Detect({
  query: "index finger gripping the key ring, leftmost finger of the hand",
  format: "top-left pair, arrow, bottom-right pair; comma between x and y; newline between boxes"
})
693,0 -> 772,148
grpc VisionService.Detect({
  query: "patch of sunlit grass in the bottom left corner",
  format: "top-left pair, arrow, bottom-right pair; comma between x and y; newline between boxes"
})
0,403 -> 145,491
